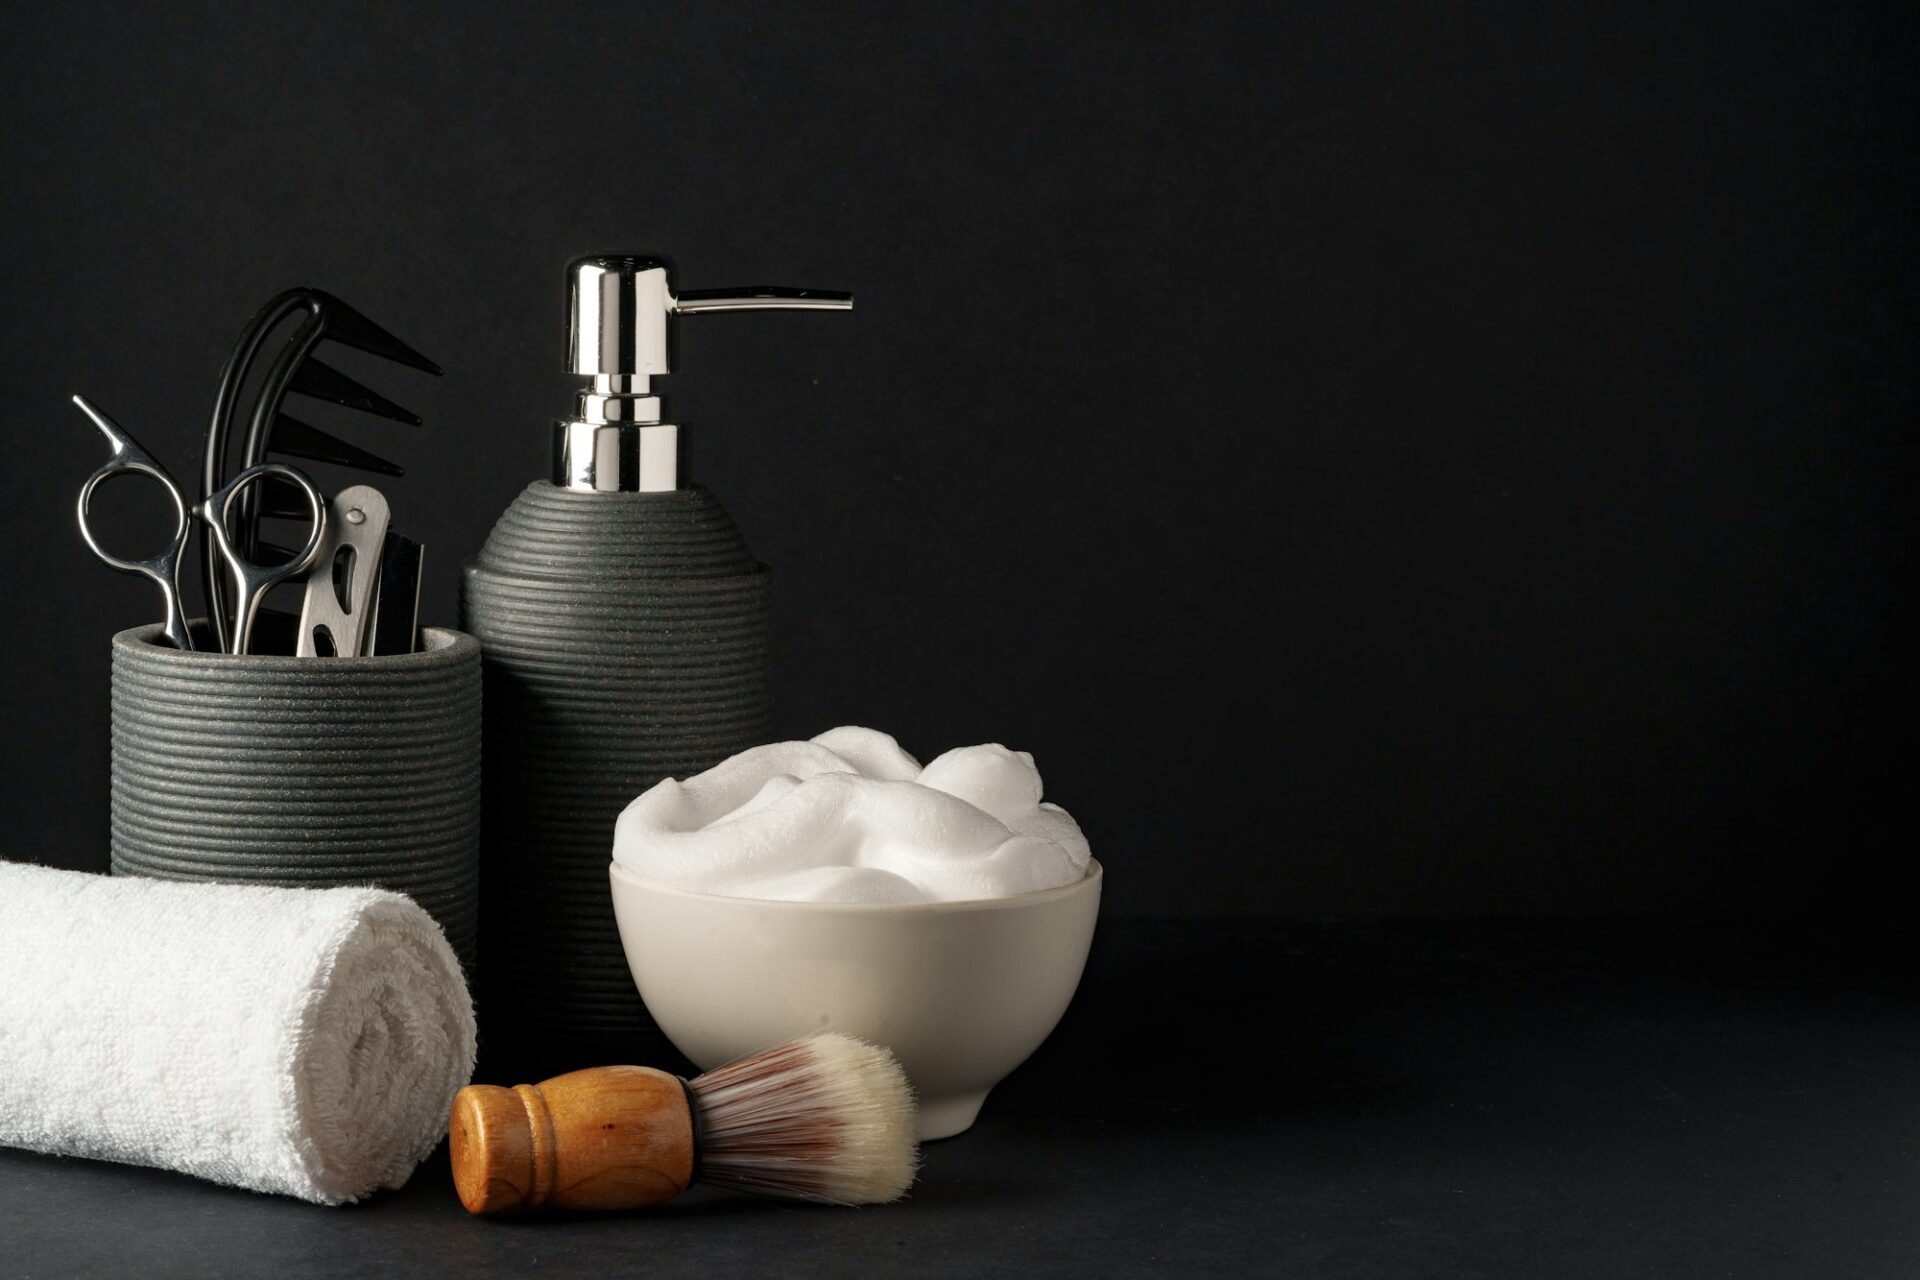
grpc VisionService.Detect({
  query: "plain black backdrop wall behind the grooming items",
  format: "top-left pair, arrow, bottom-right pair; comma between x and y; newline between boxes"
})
0,4 -> 1920,913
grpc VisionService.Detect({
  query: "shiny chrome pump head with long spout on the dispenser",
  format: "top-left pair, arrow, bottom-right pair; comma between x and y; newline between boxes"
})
553,253 -> 852,493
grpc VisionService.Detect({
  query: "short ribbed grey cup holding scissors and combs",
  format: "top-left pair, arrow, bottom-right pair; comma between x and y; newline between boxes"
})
113,626 -> 480,971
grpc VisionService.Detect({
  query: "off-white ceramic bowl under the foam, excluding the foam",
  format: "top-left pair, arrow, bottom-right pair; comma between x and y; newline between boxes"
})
611,862 -> 1102,1138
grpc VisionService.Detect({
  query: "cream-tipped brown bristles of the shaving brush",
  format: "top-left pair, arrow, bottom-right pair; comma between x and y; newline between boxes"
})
693,1032 -> 920,1205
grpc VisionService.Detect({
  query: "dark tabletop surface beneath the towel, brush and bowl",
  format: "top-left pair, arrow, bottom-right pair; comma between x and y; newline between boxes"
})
0,919 -> 1920,1278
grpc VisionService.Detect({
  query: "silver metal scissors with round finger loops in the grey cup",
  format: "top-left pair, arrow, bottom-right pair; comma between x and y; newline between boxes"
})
73,395 -> 326,652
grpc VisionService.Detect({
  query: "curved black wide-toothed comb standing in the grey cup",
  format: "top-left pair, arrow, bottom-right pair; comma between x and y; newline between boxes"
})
200,288 -> 440,647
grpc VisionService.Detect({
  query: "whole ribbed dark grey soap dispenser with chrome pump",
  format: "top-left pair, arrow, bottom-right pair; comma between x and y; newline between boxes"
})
461,255 -> 852,1071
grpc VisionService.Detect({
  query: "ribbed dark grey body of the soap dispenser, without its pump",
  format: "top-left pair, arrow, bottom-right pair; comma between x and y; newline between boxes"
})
463,482 -> 772,1065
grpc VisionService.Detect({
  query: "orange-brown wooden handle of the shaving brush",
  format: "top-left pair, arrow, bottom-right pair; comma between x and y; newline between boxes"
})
447,1067 -> 693,1213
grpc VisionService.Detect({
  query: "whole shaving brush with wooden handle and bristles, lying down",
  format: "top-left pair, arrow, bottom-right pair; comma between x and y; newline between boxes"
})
447,1032 -> 920,1213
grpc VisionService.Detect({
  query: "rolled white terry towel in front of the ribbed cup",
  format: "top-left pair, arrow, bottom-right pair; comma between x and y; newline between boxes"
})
0,862 -> 474,1205
